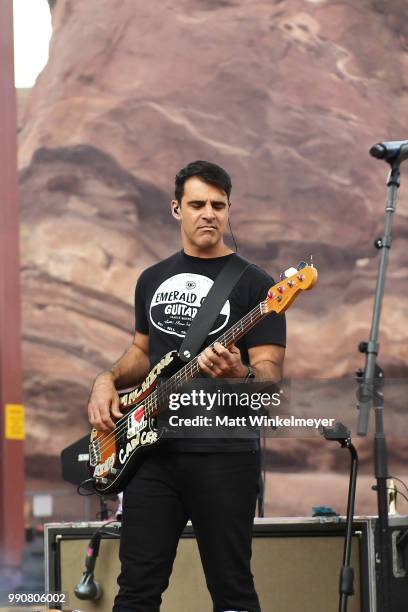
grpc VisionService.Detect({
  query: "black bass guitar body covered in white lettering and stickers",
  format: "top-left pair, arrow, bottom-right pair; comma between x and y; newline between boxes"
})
89,351 -> 184,495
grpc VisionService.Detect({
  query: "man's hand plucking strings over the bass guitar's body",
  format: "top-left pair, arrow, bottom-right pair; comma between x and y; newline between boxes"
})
88,372 -> 123,432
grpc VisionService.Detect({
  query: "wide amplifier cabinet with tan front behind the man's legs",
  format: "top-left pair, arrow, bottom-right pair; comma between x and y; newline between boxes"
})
45,517 -> 408,612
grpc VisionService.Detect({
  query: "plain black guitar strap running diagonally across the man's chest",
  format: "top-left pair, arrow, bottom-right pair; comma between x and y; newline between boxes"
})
179,254 -> 249,362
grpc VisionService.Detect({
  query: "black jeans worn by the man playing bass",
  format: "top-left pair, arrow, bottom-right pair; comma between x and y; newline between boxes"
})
113,451 -> 260,612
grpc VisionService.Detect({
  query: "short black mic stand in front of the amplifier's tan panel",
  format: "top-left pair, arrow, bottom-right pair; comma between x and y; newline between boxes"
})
320,423 -> 358,612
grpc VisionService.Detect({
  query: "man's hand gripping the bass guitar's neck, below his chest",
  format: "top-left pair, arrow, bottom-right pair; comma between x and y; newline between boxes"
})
197,342 -> 248,378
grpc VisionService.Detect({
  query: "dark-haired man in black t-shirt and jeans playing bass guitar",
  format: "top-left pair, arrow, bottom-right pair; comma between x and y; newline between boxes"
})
88,161 -> 286,612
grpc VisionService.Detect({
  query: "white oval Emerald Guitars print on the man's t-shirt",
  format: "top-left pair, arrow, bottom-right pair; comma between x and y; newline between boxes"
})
150,273 -> 230,338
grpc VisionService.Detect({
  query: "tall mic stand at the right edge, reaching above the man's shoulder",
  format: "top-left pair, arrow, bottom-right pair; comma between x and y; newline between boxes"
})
357,156 -> 400,612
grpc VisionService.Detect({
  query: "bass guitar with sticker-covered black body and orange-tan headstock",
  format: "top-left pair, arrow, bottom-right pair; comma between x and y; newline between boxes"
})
89,264 -> 317,494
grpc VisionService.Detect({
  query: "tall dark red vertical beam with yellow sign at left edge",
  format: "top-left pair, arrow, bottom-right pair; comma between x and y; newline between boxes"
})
0,0 -> 24,565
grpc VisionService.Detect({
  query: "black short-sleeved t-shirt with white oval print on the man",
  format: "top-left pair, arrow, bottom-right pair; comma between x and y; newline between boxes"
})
135,251 -> 286,452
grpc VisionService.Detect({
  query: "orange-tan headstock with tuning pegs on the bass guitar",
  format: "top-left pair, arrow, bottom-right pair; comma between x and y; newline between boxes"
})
264,262 -> 317,313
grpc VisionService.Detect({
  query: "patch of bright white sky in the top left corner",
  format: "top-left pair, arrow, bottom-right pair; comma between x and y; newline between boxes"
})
13,0 -> 51,87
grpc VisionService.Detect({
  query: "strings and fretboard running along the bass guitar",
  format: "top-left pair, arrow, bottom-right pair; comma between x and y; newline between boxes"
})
91,299 -> 269,462
